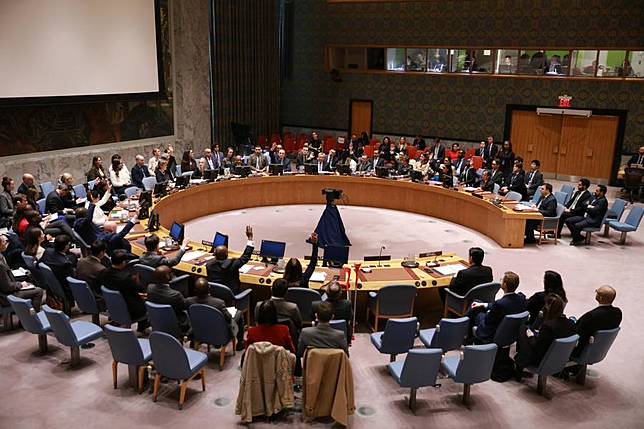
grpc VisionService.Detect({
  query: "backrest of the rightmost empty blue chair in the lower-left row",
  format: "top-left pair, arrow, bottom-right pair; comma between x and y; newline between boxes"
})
150,331 -> 192,380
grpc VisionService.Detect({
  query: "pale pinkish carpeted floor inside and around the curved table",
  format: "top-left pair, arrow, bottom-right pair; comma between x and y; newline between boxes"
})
0,181 -> 644,429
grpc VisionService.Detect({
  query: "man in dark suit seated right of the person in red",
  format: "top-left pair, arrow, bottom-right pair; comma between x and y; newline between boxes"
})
297,301 -> 349,357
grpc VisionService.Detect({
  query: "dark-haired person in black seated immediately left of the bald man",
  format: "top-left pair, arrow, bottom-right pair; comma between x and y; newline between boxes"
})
514,293 -> 575,372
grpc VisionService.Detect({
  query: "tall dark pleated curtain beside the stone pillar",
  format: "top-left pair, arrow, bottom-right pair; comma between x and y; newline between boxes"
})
211,0 -> 280,147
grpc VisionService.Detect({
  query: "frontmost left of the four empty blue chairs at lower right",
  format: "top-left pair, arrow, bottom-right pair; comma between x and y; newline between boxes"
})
387,349 -> 442,412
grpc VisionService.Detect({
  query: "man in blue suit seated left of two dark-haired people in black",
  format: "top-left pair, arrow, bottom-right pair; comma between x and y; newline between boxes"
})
467,271 -> 526,342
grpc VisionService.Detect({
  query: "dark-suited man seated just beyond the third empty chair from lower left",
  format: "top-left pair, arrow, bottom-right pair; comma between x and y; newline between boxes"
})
101,249 -> 148,332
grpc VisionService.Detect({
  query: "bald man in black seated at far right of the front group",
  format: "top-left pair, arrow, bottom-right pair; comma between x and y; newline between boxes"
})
573,286 -> 622,356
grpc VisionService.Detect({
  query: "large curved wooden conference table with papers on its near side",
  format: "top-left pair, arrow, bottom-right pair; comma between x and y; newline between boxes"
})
123,175 -> 542,316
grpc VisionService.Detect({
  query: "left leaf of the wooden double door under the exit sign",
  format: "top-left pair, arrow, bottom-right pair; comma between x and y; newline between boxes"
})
510,110 -> 562,174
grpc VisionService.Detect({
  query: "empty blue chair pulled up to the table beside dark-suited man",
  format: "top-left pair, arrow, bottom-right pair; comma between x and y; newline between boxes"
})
367,285 -> 416,331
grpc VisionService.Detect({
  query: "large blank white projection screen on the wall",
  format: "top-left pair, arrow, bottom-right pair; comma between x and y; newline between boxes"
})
0,0 -> 159,98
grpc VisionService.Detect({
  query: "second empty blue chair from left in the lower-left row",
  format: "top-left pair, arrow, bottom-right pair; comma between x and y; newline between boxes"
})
43,305 -> 103,366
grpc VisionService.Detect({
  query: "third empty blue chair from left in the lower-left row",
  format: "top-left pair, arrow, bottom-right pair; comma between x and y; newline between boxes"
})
104,325 -> 152,394
